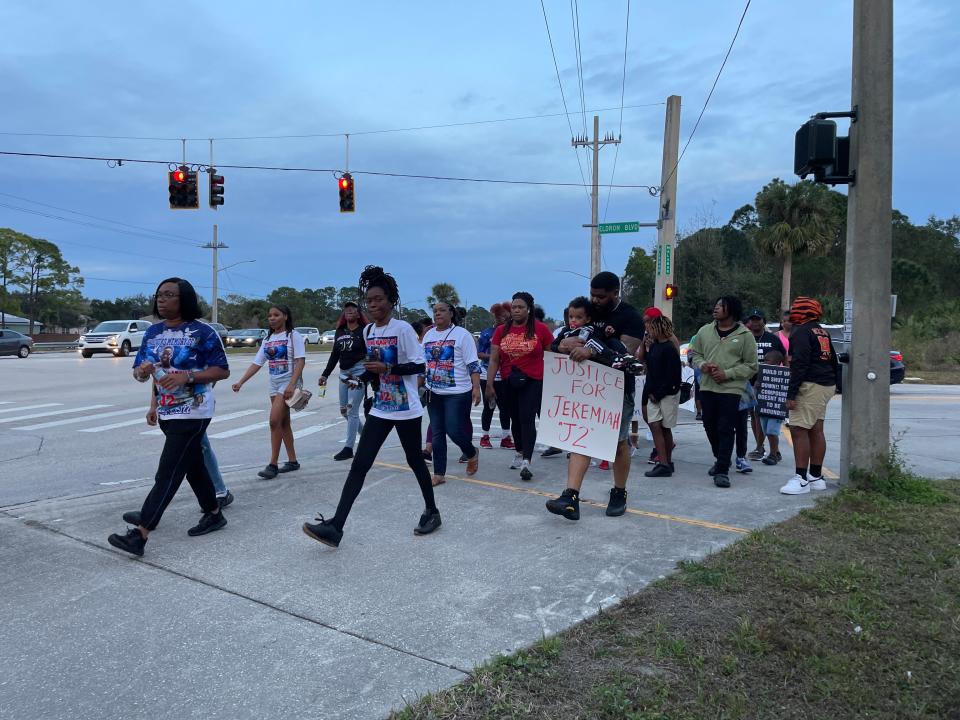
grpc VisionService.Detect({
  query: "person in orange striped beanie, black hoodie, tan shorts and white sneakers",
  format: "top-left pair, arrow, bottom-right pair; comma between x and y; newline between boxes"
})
780,297 -> 839,495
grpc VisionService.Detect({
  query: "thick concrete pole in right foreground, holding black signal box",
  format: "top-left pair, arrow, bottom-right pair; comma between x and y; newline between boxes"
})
840,0 -> 893,483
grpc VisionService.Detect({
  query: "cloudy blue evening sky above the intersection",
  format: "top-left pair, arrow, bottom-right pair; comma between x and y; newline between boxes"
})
0,0 -> 960,315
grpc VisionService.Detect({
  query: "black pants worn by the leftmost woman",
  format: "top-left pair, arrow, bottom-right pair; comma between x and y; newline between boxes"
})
140,419 -> 220,530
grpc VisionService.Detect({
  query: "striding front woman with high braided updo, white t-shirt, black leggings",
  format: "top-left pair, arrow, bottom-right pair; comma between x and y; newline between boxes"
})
303,265 -> 440,547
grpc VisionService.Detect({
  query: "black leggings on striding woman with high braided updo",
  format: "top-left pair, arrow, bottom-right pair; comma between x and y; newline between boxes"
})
332,415 -> 437,531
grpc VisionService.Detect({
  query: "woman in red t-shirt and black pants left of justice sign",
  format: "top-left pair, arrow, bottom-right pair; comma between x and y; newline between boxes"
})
486,292 -> 553,480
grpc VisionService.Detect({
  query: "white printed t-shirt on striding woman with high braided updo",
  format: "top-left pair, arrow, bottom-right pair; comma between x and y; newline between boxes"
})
363,318 -> 423,420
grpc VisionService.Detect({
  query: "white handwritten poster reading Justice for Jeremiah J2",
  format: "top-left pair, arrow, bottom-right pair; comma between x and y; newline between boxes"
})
537,352 -> 623,462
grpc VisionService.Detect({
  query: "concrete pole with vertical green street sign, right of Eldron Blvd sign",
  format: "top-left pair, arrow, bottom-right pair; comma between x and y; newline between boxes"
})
653,95 -> 680,317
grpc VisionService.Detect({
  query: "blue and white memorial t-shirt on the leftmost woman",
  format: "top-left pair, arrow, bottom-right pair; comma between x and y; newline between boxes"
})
133,320 -> 229,420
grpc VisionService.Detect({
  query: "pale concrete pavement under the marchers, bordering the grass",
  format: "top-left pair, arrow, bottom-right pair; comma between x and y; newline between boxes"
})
0,416 -> 838,720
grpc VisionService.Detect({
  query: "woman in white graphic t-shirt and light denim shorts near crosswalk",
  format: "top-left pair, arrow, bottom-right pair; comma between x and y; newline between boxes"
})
233,305 -> 307,480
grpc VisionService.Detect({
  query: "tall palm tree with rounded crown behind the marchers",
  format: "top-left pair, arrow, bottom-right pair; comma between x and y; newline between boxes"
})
755,178 -> 837,310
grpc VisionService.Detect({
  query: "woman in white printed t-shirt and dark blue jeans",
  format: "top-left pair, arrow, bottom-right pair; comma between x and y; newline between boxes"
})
423,300 -> 480,485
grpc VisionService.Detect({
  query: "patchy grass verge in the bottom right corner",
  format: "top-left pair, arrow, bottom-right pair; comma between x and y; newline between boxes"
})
392,465 -> 960,720
